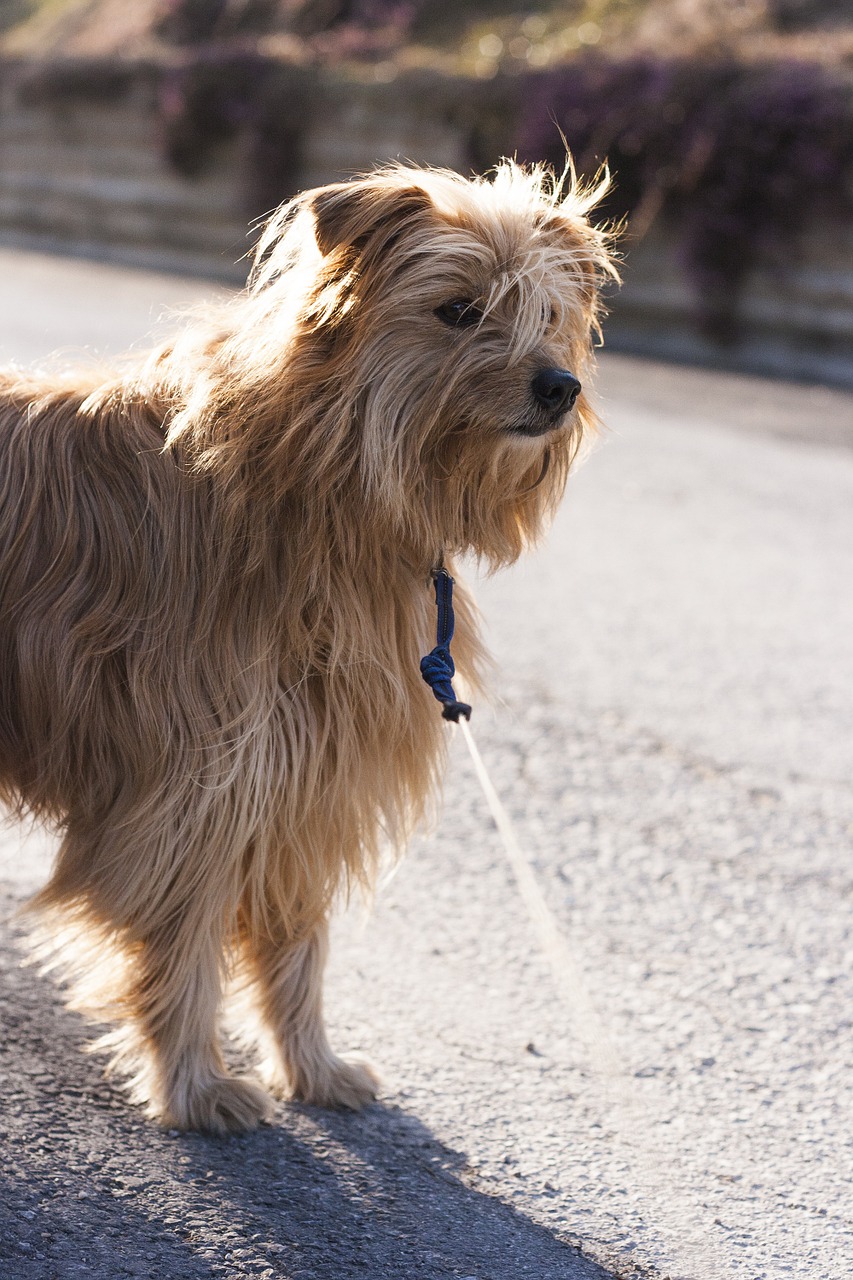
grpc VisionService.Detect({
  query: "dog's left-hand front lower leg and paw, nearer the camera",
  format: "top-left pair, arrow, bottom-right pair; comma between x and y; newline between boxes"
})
129,915 -> 270,1133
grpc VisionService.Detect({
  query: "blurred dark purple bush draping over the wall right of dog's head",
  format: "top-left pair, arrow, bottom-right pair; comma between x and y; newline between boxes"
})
519,55 -> 853,337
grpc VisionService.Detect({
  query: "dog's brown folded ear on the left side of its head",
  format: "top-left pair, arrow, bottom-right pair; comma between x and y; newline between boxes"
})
310,179 -> 432,257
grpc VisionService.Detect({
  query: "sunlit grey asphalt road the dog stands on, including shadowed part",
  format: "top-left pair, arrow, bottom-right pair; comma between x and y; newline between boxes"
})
0,241 -> 853,1280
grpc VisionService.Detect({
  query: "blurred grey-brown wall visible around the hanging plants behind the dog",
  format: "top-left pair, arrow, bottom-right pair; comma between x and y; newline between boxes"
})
0,63 -> 853,385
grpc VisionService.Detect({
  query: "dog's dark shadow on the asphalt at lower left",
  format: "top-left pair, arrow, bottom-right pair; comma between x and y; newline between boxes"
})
0,901 -> 605,1280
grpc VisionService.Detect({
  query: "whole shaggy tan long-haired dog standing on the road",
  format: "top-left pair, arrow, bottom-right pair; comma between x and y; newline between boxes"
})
0,161 -> 613,1133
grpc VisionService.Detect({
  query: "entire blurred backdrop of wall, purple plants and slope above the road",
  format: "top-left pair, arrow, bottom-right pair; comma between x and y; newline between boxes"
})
0,0 -> 853,384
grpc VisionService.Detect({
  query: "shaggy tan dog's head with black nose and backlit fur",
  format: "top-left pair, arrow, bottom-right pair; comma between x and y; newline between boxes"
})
251,161 -> 615,563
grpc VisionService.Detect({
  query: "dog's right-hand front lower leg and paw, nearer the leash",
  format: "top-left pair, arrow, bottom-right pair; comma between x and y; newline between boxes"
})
245,920 -> 378,1111
